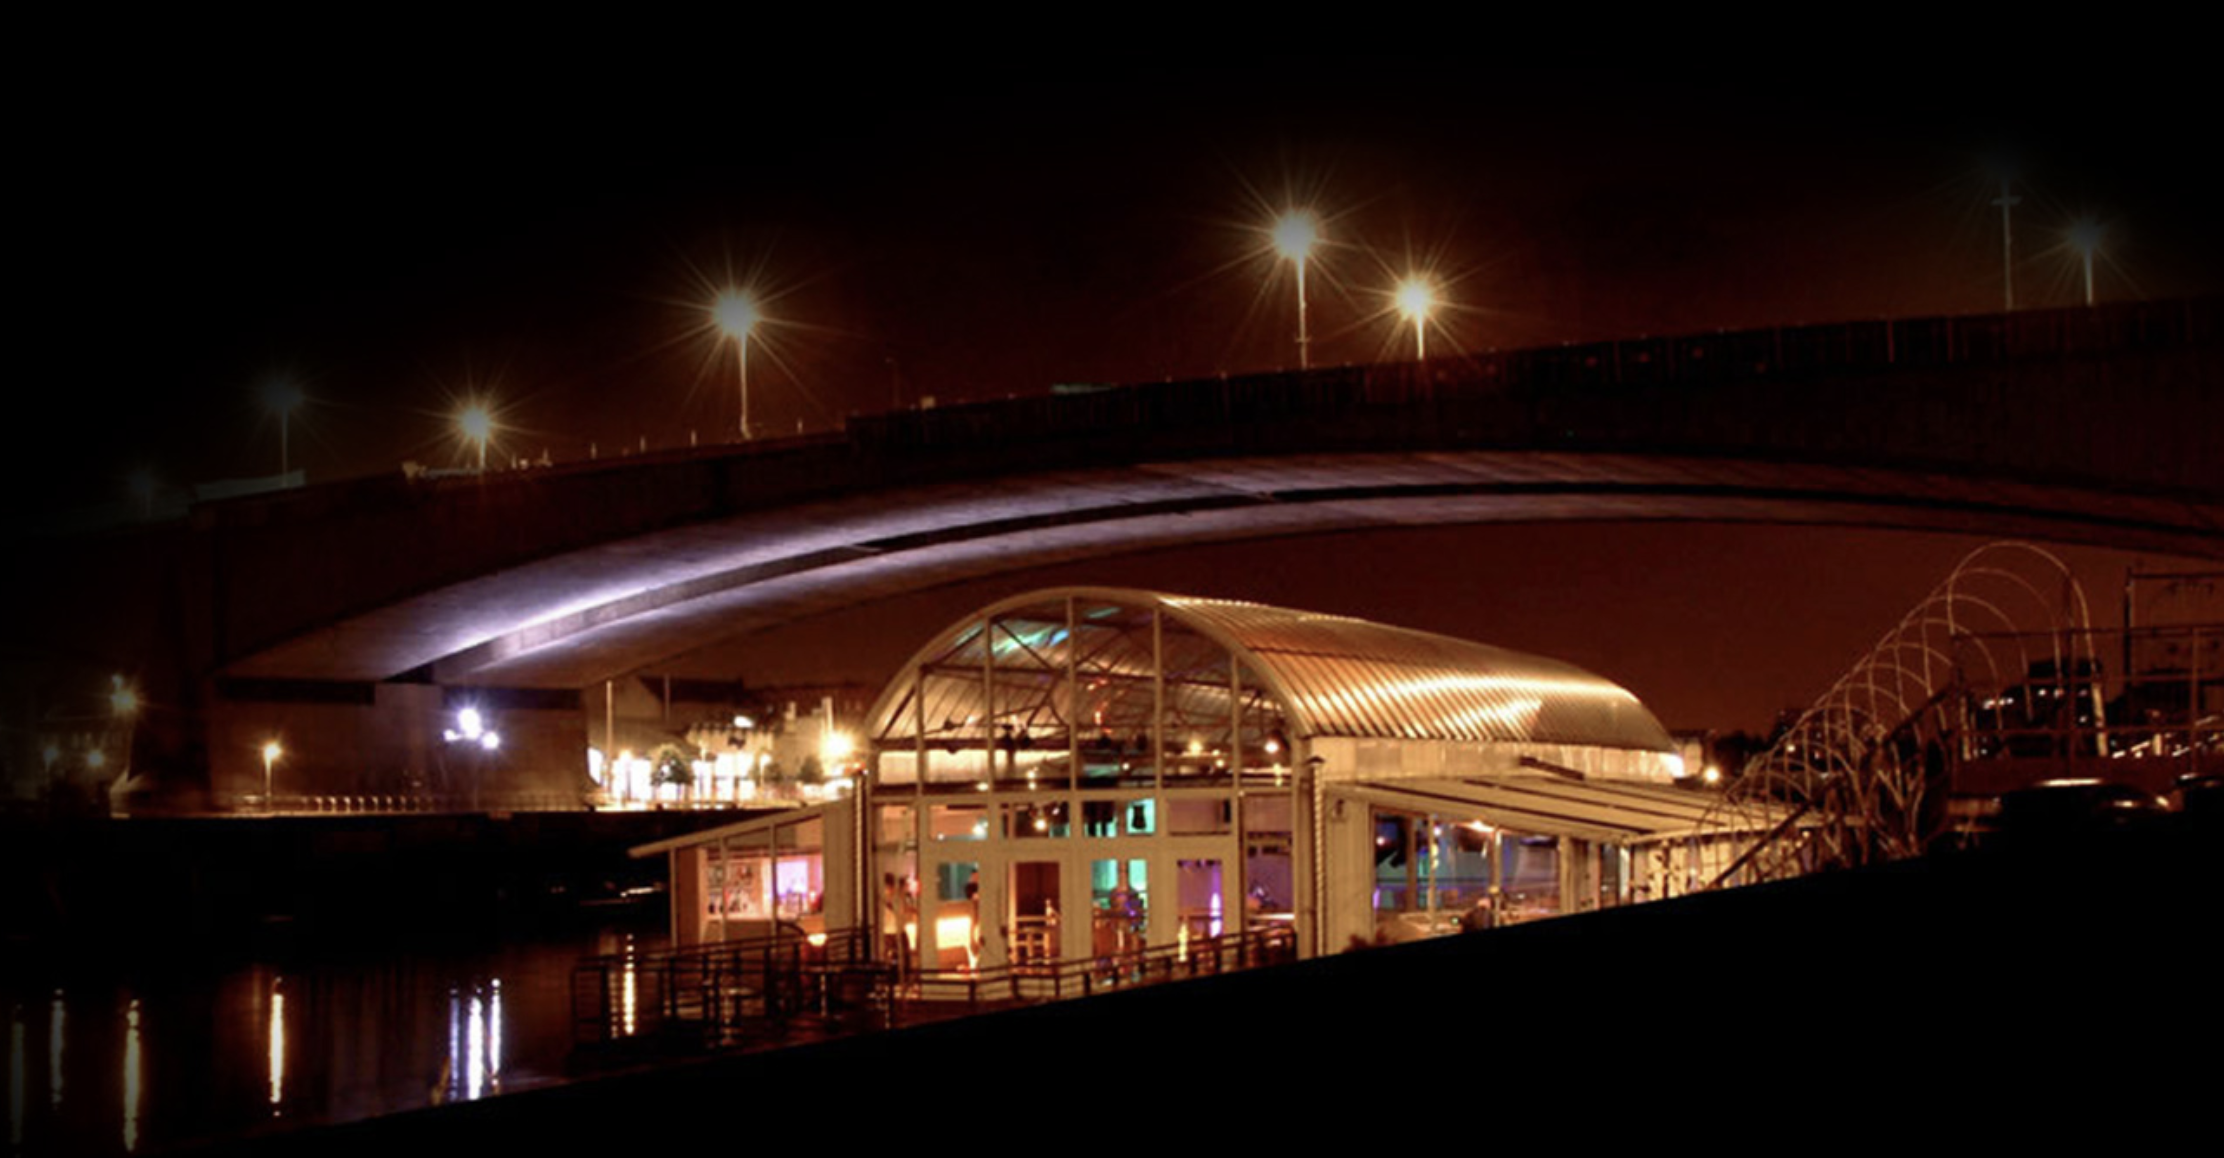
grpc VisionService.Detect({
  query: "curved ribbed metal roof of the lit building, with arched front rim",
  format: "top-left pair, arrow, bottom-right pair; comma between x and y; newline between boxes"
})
872,587 -> 1675,753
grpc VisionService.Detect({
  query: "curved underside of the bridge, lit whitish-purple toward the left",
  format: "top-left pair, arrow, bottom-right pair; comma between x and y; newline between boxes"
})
227,451 -> 2224,689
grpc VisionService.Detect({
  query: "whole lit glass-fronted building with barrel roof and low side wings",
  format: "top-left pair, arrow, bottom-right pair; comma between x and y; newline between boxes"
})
641,587 -> 1737,971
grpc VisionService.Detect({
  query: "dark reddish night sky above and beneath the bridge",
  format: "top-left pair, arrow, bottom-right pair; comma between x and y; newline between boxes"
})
9,58 -> 2224,727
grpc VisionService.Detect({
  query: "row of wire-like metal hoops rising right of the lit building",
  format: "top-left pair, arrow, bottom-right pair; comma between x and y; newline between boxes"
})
1708,542 -> 2104,885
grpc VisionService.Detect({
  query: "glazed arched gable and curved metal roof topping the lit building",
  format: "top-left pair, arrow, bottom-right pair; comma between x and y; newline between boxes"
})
867,587 -> 1679,789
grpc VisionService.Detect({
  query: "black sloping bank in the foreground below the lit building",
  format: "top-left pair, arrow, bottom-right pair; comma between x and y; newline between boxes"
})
169,818 -> 2224,1158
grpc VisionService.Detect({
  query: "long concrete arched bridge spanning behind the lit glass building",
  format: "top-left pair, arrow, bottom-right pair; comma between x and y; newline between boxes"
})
21,300 -> 2224,800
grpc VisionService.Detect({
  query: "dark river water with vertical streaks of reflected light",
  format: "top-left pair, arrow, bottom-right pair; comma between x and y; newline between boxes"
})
0,925 -> 663,1158
